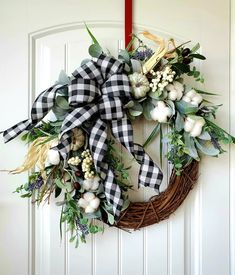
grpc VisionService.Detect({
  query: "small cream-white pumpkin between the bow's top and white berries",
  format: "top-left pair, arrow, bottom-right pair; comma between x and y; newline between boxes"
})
129,72 -> 150,99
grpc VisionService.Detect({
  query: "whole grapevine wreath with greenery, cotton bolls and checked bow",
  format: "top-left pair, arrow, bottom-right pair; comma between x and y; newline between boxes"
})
3,26 -> 235,245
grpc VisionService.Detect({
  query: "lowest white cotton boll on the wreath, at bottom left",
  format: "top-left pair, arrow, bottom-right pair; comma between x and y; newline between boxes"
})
78,192 -> 100,213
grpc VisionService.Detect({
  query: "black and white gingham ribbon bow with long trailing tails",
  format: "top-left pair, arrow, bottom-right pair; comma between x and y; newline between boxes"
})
3,54 -> 163,218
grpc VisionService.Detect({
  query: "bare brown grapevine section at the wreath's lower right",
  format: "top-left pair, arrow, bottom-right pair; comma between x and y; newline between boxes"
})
117,161 -> 199,230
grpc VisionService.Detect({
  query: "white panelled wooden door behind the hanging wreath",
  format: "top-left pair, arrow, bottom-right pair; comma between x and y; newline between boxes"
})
0,0 -> 235,275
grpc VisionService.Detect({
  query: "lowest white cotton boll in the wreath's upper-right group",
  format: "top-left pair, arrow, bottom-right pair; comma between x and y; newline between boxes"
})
184,116 -> 205,137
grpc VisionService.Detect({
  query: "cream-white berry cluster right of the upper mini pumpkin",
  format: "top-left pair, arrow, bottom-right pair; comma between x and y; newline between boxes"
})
149,66 -> 176,92
